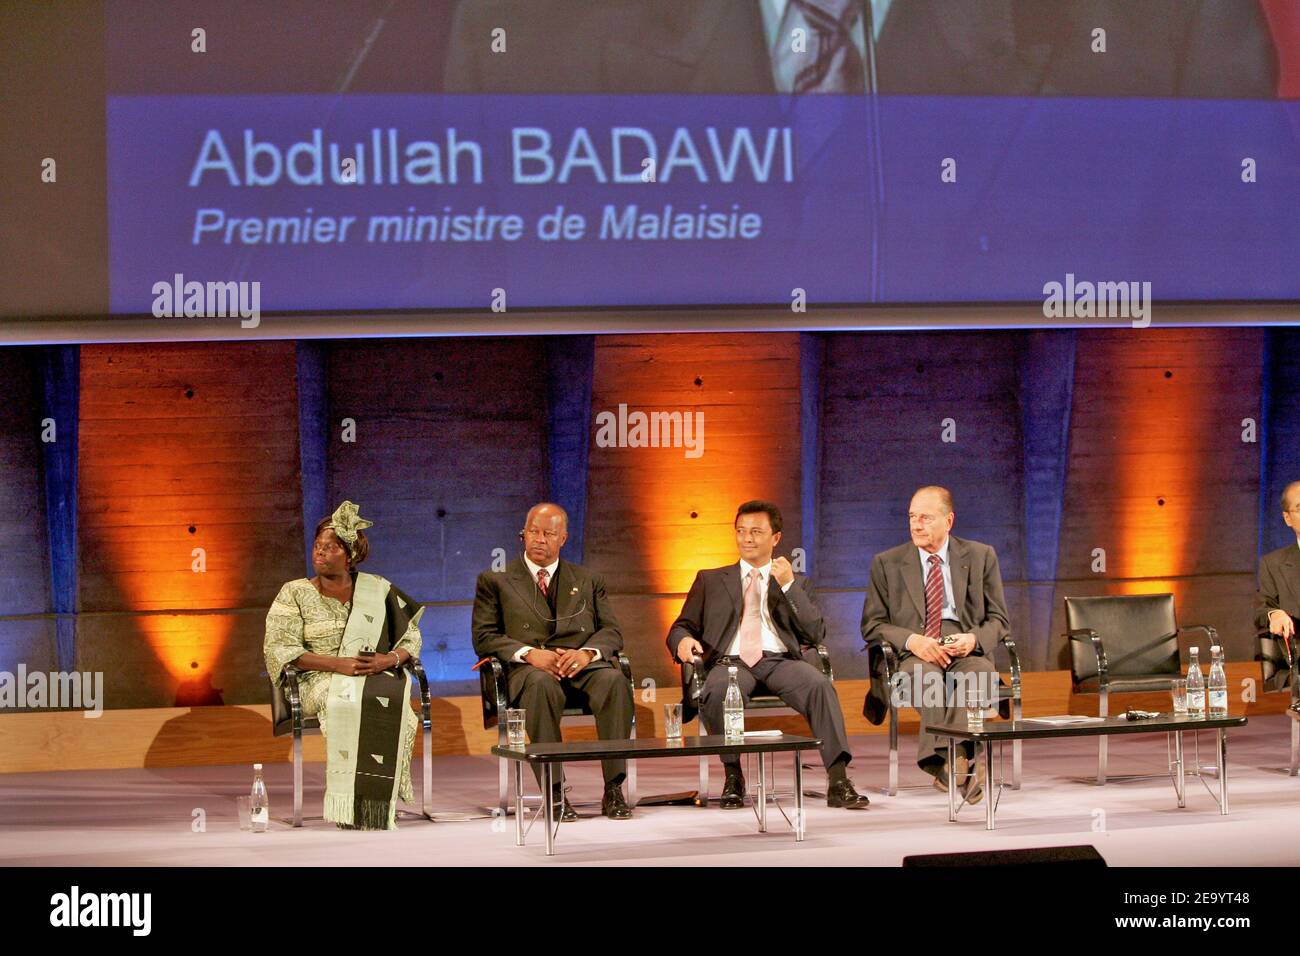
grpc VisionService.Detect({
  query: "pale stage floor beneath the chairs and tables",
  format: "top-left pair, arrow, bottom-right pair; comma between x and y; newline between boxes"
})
0,715 -> 1300,866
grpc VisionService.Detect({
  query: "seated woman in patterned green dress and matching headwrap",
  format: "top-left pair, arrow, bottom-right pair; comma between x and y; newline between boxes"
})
265,501 -> 423,830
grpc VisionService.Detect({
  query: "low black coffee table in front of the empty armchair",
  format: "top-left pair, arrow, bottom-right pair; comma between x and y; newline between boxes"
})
930,713 -> 1245,830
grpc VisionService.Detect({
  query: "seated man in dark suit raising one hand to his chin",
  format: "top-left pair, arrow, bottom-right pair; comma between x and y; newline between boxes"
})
668,501 -> 868,810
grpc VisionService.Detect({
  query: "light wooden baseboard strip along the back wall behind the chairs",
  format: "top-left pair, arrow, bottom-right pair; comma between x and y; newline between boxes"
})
0,662 -> 1290,774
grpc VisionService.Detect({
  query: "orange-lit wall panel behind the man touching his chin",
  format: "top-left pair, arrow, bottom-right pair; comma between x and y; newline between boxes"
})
586,333 -> 802,683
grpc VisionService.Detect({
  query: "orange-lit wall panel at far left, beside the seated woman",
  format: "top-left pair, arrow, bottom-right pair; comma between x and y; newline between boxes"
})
77,342 -> 302,708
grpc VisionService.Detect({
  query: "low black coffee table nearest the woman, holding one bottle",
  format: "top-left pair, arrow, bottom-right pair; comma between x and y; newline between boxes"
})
491,734 -> 822,856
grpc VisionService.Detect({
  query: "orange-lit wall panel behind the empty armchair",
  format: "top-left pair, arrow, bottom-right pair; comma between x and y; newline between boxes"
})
1048,329 -> 1262,667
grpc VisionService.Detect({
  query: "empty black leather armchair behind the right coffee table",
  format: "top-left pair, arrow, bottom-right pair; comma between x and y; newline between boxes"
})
1065,594 -> 1218,786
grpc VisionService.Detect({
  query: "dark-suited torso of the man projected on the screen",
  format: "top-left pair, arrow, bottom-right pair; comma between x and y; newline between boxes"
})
446,0 -> 1278,98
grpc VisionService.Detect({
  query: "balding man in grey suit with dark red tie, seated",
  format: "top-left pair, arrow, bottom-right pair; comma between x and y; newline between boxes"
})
862,485 -> 1008,803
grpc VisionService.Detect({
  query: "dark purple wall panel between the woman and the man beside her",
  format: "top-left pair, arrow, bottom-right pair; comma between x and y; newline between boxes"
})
329,338 -> 546,606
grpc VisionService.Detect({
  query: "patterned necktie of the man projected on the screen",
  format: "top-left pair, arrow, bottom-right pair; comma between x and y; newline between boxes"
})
772,0 -> 865,94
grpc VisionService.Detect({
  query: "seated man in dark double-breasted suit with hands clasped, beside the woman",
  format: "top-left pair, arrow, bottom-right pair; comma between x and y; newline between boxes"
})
473,503 -> 633,821
